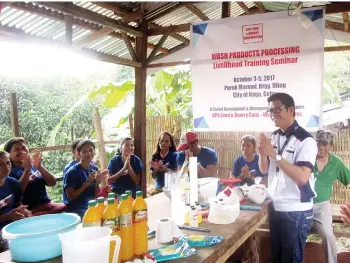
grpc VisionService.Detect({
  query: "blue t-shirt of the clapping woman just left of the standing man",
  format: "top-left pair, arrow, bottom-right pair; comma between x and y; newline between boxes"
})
232,154 -> 267,185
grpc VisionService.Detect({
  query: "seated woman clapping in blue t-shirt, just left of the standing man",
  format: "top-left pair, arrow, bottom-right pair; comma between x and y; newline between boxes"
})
232,135 -> 267,186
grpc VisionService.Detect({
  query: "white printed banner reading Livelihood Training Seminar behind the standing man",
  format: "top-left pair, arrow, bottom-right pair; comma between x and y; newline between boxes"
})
191,8 -> 325,131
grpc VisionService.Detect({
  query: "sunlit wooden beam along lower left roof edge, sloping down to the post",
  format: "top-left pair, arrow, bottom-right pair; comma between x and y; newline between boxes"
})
0,25 -> 141,67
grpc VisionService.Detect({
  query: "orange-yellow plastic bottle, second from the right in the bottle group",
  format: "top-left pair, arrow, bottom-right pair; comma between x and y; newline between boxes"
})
118,194 -> 134,261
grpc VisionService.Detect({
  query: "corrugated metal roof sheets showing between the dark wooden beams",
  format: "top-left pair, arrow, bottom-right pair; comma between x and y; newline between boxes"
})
0,1 -> 343,65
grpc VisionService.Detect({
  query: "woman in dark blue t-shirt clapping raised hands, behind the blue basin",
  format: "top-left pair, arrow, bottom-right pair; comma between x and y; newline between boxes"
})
4,137 -> 66,215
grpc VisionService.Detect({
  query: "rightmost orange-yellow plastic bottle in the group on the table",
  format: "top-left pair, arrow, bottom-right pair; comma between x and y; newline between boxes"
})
132,191 -> 148,256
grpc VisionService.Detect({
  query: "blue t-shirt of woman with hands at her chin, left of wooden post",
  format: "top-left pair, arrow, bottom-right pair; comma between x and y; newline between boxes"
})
108,154 -> 142,198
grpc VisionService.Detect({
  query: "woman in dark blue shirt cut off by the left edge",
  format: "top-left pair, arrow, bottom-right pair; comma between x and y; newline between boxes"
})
0,151 -> 31,253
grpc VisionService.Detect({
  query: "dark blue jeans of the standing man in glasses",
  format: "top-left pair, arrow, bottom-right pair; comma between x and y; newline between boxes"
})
269,202 -> 313,263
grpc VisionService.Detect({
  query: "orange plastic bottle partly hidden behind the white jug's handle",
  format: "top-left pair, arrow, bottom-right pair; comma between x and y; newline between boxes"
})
102,198 -> 121,263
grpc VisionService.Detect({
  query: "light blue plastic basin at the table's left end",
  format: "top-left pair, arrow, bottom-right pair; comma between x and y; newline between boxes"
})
2,213 -> 80,262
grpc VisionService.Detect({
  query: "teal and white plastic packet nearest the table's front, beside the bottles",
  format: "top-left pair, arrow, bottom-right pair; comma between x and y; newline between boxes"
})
148,237 -> 197,262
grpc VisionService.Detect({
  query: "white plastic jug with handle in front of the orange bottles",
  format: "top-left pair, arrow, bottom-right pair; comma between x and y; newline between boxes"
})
58,227 -> 121,263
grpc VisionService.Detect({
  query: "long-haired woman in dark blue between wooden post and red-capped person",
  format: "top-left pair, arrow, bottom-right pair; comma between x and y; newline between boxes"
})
147,132 -> 177,195
